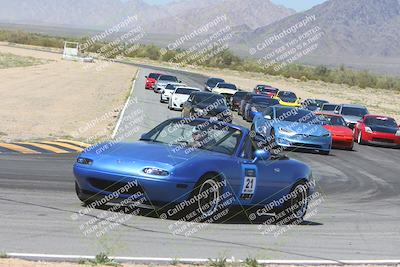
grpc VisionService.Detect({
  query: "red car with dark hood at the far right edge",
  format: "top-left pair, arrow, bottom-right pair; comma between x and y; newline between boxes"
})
354,115 -> 400,146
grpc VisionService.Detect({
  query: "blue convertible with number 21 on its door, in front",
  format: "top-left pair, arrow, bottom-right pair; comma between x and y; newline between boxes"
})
74,118 -> 313,220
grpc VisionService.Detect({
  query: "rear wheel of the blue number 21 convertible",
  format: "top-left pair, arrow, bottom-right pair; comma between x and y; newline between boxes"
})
276,182 -> 308,224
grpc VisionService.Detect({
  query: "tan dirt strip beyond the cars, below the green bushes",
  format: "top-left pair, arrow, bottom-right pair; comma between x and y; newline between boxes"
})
127,59 -> 400,123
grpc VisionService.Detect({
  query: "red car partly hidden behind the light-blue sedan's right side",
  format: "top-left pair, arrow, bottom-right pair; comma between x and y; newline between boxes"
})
316,112 -> 354,150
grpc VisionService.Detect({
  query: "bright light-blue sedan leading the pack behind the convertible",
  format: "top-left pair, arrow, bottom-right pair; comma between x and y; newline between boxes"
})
251,106 -> 332,155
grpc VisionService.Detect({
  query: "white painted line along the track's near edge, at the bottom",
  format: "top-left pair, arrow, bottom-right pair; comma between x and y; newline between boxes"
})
6,253 -> 400,265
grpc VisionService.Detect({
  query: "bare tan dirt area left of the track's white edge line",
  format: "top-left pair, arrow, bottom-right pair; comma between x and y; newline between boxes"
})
0,43 -> 137,143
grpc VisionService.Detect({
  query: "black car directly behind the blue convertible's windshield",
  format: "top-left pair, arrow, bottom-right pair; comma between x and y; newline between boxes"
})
182,92 -> 233,123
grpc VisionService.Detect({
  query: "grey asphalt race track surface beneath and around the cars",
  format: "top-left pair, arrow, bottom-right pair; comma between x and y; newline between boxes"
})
0,66 -> 400,260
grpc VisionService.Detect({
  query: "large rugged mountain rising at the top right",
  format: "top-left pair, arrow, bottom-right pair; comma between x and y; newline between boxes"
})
234,0 -> 400,74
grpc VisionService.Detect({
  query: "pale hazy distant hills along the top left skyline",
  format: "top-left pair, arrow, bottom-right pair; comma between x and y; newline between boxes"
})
0,0 -> 295,34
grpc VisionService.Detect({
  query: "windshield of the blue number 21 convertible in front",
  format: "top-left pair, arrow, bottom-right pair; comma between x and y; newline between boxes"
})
140,120 -> 243,155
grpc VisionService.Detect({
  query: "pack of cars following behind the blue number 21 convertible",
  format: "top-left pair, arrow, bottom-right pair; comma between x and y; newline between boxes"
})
145,73 -> 400,154
